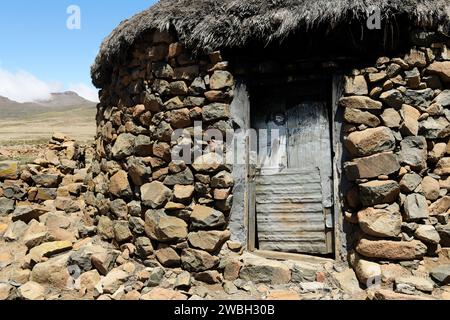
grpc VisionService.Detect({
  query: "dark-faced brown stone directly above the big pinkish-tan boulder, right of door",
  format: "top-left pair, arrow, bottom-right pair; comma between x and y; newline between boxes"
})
359,180 -> 400,207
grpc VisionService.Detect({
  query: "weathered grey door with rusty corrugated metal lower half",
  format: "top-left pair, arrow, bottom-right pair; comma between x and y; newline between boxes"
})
254,96 -> 333,254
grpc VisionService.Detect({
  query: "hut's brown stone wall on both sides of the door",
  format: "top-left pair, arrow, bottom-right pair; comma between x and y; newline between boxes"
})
86,26 -> 450,285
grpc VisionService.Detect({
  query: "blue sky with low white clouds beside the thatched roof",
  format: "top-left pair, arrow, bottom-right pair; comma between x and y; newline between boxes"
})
0,0 -> 156,101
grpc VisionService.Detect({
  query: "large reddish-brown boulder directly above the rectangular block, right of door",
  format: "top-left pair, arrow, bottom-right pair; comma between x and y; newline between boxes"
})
345,127 -> 395,157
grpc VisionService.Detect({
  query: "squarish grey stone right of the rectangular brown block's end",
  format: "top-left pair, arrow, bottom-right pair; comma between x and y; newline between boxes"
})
399,137 -> 427,170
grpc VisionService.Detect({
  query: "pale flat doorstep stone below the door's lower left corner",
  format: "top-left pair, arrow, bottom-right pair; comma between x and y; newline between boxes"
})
240,257 -> 291,285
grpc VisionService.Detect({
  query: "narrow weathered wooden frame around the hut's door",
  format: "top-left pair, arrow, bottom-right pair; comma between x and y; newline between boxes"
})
245,74 -> 345,261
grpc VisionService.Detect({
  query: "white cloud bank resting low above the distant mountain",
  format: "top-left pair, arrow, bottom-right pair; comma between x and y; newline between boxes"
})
0,68 -> 62,102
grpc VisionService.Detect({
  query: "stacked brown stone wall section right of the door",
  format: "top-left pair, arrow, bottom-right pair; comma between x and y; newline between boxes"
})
340,43 -> 450,284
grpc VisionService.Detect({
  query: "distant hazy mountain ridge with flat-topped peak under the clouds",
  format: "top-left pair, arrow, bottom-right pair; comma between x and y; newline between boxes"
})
0,91 -> 96,119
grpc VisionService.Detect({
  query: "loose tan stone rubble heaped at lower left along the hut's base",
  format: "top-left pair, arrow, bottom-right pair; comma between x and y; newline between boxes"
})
0,134 -> 361,300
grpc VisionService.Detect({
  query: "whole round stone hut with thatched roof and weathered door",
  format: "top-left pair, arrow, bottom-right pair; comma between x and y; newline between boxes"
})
86,0 -> 450,285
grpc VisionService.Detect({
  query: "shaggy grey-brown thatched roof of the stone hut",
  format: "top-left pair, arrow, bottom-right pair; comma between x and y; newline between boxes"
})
92,0 -> 450,87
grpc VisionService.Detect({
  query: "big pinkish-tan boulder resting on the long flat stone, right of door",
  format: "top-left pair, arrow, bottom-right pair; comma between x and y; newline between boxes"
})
358,208 -> 402,237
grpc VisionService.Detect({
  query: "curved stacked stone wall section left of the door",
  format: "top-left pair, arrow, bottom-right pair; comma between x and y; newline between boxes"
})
86,32 -> 239,282
